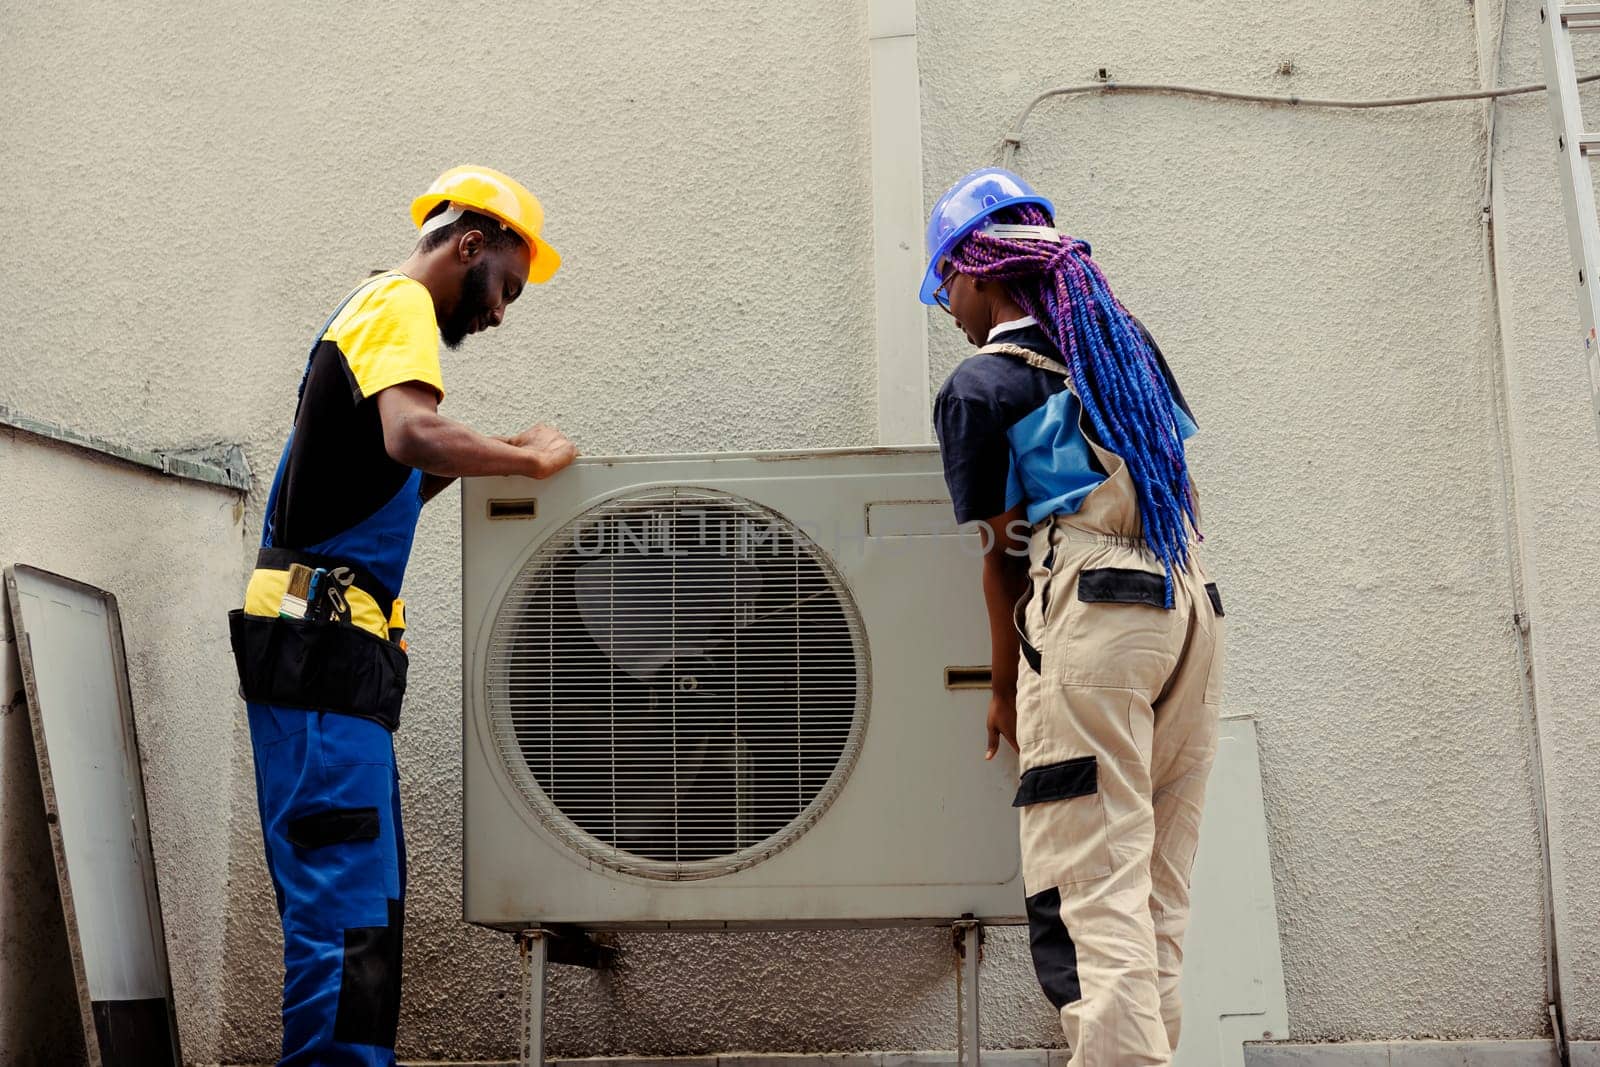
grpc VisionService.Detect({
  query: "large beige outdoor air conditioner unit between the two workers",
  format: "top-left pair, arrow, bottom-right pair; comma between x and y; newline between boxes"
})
462,448 -> 1022,929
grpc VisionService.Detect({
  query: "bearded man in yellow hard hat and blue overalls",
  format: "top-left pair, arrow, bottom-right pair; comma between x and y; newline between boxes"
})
229,166 -> 576,1067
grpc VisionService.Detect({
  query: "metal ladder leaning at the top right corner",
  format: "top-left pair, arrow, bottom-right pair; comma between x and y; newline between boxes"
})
1539,0 -> 1600,444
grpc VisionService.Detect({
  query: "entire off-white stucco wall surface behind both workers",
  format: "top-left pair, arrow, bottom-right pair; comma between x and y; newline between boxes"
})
0,0 -> 1600,1062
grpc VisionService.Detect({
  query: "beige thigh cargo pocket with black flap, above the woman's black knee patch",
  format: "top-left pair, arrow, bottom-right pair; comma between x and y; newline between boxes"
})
1011,755 -> 1110,885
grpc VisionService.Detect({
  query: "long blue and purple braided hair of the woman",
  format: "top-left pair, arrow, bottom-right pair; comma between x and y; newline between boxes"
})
950,203 -> 1198,606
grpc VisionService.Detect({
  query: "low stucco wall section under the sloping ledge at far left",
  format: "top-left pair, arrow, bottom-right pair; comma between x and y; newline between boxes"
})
0,430 -> 243,1064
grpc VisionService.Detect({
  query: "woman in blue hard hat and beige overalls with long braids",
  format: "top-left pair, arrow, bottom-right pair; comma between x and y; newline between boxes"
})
922,168 -> 1222,1067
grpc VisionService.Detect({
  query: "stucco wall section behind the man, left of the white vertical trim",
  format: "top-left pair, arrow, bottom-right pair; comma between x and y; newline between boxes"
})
9,2 -> 928,1061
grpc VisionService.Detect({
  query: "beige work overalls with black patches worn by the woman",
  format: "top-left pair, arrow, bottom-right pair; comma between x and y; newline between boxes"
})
982,344 -> 1222,1067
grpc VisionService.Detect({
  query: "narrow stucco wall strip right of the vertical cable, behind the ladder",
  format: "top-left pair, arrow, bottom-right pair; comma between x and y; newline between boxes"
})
1494,0 -> 1600,1040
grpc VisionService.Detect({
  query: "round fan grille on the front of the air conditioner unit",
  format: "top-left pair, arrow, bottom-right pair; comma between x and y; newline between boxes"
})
485,488 -> 869,878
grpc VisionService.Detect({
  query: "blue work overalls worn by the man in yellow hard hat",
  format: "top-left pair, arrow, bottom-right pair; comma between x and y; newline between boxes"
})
230,279 -> 422,1067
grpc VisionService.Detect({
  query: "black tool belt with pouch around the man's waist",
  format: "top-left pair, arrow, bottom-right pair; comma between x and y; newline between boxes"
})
227,549 -> 406,733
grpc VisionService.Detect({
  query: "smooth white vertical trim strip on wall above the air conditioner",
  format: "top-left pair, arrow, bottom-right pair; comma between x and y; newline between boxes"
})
867,0 -> 933,445
